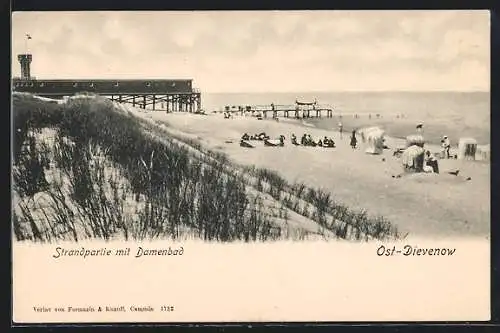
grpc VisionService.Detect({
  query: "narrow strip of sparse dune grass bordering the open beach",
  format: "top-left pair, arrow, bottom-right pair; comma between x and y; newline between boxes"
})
132,110 -> 407,240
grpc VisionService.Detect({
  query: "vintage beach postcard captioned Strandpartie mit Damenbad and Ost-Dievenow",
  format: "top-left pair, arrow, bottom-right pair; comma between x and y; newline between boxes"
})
11,10 -> 490,324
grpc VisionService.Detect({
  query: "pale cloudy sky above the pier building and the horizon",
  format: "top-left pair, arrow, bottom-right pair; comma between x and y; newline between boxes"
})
12,10 -> 490,92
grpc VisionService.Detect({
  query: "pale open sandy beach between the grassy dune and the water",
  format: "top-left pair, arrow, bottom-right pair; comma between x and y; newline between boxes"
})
132,112 -> 490,236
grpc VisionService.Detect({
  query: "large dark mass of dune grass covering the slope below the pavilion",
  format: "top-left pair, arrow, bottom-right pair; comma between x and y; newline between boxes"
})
13,97 -> 281,241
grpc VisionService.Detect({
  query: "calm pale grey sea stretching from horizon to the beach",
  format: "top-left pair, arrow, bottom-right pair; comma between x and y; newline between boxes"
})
202,92 -> 490,144
